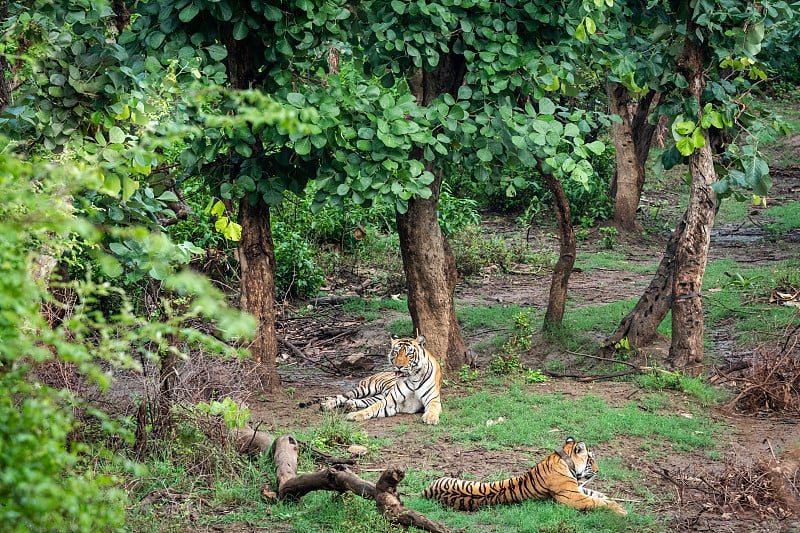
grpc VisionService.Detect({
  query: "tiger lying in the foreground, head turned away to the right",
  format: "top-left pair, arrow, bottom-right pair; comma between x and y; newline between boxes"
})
422,437 -> 628,515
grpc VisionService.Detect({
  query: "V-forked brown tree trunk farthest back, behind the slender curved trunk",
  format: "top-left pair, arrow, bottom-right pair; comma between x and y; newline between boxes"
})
607,83 -> 657,232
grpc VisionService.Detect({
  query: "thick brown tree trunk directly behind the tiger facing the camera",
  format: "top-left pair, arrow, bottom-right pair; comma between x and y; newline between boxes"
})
396,54 -> 469,371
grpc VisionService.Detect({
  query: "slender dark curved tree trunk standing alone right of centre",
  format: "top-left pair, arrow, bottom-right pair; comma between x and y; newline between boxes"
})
539,167 -> 576,330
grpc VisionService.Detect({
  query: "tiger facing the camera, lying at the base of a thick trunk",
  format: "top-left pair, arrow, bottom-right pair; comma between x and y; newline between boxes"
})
301,335 -> 442,424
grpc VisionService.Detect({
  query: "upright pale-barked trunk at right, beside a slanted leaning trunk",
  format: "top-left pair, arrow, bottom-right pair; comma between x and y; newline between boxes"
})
667,32 -> 716,375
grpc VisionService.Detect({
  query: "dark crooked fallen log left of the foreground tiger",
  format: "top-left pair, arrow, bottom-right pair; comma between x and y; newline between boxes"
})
268,435 -> 451,533
